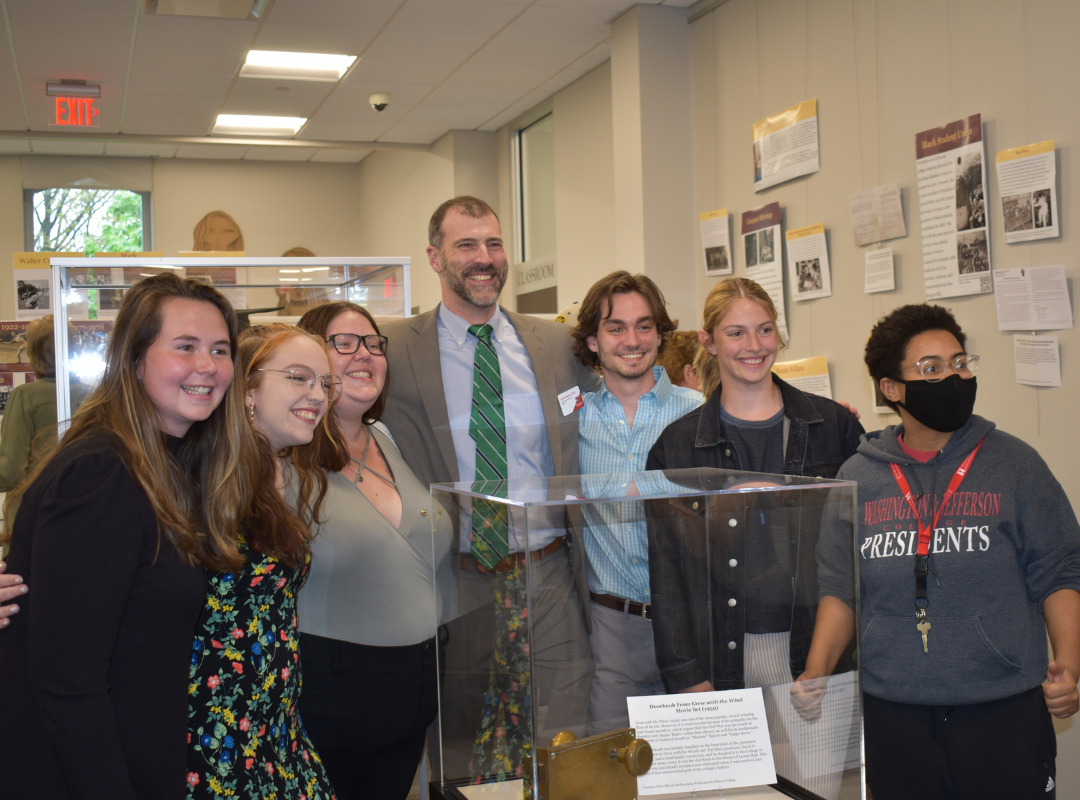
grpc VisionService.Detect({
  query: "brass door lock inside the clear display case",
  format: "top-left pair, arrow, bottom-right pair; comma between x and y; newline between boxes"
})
537,728 -> 652,800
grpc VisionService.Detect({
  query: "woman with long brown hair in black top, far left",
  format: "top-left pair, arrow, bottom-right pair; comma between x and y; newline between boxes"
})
0,274 -> 267,799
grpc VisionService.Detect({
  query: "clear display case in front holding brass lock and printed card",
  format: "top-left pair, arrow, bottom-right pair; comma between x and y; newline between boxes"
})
429,469 -> 865,800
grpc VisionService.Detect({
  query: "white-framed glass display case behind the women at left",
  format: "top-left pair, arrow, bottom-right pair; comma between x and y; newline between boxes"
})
51,256 -> 411,420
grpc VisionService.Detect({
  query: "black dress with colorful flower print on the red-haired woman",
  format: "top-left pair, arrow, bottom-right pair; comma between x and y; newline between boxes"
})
188,541 -> 334,800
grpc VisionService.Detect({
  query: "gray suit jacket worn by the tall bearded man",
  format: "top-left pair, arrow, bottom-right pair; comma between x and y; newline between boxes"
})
382,307 -> 600,615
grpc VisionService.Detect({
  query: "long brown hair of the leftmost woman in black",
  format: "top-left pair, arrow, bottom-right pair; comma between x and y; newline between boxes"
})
4,272 -> 258,572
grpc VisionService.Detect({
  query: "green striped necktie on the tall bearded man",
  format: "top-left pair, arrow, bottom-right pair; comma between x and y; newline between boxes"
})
469,325 -> 510,569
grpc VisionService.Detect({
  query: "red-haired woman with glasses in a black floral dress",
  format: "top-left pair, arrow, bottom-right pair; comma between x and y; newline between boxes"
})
187,324 -> 346,800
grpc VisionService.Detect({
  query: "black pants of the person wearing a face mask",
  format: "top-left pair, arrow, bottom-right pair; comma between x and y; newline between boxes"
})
863,687 -> 1057,800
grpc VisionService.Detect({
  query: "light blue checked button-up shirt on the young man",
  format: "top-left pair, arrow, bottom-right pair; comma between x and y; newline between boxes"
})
578,366 -> 704,602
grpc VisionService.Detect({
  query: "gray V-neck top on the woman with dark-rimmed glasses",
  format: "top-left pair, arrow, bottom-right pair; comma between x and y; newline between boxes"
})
299,426 -> 453,647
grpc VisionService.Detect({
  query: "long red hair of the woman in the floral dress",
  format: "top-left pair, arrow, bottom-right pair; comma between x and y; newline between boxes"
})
240,323 -> 349,541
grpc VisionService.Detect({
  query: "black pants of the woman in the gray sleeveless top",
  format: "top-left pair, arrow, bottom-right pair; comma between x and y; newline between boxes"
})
300,634 -> 438,800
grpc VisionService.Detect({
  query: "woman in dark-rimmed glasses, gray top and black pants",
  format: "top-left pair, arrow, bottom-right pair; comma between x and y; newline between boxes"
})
299,302 -> 451,800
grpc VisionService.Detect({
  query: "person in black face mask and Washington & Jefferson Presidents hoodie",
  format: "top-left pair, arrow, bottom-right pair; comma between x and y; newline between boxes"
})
793,304 -> 1080,800
